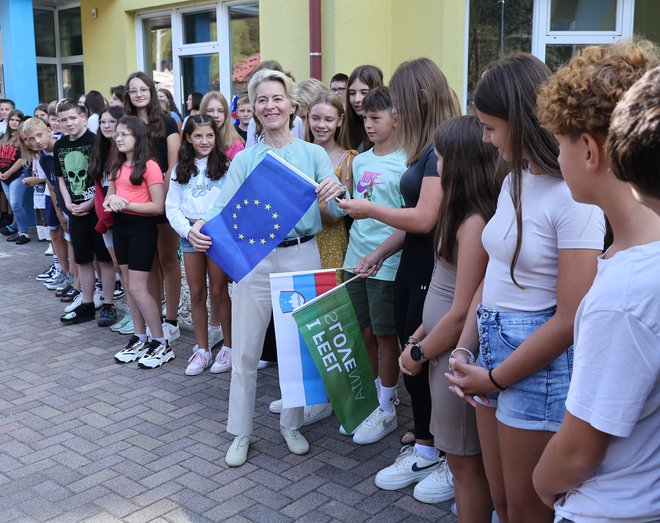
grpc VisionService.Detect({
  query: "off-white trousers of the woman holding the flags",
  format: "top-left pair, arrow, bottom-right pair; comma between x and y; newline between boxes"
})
227,239 -> 321,436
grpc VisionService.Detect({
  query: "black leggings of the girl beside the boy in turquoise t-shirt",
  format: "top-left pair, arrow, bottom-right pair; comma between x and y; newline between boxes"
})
394,234 -> 434,440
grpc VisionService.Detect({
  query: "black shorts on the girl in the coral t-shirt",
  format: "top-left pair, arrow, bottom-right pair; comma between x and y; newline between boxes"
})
112,212 -> 158,272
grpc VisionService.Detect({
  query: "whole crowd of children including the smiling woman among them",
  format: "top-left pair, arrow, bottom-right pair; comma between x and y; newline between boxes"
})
0,42 -> 660,523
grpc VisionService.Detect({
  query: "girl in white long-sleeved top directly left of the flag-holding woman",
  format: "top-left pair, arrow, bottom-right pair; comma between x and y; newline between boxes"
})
165,113 -> 231,376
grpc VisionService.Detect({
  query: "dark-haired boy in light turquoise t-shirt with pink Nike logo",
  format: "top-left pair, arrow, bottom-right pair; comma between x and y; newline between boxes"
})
344,87 -> 406,444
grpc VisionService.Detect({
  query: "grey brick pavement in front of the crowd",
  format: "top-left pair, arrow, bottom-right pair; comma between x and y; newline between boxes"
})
0,238 -> 455,523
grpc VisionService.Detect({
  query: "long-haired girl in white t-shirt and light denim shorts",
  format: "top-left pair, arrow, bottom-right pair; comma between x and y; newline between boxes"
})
447,54 -> 605,522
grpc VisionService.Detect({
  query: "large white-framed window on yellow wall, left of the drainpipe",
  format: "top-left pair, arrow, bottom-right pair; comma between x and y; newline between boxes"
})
136,1 -> 259,114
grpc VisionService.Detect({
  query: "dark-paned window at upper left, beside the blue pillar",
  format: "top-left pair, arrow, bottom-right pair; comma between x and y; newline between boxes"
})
33,5 -> 85,102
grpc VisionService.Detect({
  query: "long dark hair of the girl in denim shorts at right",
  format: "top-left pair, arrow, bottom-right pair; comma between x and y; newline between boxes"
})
474,53 -> 562,288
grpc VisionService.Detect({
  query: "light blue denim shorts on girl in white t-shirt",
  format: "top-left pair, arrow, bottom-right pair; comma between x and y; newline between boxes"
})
477,305 -> 573,432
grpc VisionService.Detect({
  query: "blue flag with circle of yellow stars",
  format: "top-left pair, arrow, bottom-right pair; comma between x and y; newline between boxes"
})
201,151 -> 316,282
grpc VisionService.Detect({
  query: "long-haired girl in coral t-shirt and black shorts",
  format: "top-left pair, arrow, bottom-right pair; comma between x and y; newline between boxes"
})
103,116 -> 174,369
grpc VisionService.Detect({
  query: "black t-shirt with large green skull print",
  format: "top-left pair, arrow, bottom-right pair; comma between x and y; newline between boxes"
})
53,130 -> 96,204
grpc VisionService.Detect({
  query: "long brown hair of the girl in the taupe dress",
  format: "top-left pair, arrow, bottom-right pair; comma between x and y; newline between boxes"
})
433,116 -> 502,263
